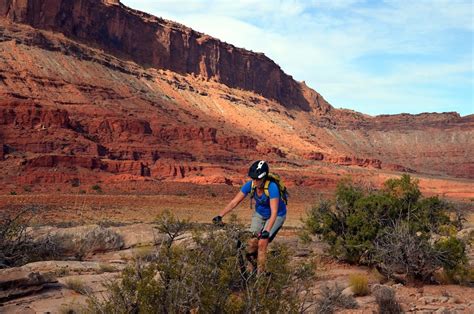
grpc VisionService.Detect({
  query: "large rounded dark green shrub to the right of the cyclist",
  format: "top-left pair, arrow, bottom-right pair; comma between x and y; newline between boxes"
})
304,175 -> 466,280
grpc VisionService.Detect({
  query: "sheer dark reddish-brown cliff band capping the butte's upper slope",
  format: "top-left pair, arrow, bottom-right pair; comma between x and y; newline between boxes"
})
0,0 -> 331,111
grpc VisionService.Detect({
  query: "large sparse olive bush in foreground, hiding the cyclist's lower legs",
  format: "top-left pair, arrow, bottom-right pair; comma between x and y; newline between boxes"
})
89,212 -> 312,313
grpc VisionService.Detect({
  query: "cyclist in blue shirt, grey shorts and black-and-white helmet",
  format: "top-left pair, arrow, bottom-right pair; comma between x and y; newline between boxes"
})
212,160 -> 286,273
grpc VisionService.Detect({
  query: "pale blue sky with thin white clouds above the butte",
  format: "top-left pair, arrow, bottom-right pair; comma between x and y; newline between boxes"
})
121,0 -> 474,115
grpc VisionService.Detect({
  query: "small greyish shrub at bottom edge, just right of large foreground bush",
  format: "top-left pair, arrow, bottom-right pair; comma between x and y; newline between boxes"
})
316,284 -> 358,314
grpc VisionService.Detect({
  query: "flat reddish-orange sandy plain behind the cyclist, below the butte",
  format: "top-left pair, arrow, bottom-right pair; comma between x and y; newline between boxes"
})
0,180 -> 474,231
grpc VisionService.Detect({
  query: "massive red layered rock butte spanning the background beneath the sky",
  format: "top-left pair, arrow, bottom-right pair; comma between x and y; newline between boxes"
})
0,0 -> 474,195
